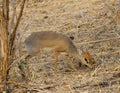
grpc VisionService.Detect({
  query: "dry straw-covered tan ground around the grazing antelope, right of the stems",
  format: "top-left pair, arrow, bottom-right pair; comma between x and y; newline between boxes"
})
8,0 -> 120,93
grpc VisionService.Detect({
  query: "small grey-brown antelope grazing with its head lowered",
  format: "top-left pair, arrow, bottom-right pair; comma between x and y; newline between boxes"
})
25,31 -> 93,74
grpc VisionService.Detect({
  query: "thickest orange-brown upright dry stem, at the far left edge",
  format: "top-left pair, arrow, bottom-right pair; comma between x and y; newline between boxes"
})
0,0 -> 9,90
